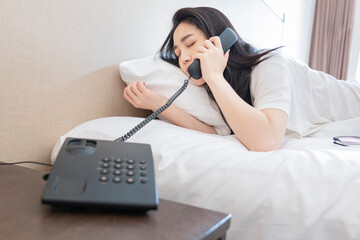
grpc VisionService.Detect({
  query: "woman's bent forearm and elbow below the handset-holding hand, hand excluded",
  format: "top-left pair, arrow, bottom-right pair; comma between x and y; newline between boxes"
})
208,76 -> 288,151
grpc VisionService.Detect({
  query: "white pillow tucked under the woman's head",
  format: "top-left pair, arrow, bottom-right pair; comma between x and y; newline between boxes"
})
119,56 -> 231,135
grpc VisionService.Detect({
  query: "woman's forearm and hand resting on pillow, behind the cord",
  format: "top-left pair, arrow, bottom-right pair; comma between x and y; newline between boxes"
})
124,82 -> 217,134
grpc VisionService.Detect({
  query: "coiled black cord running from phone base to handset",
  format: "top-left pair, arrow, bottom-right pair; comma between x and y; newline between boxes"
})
115,76 -> 191,142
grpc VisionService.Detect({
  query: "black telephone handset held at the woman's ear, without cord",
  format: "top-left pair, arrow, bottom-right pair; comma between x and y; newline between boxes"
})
188,28 -> 238,80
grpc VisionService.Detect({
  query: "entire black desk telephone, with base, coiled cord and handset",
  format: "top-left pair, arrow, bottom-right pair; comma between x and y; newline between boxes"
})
41,28 -> 238,211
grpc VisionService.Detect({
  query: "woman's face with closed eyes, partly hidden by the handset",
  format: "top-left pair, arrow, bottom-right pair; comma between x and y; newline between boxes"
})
173,22 -> 206,86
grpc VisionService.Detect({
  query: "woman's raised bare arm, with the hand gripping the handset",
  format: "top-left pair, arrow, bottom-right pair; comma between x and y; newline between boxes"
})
193,37 -> 287,151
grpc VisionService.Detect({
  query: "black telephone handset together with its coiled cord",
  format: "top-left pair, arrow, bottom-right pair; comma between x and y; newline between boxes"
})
115,28 -> 238,142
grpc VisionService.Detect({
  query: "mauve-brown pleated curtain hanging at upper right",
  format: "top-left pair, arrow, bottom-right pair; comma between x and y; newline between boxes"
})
309,0 -> 355,79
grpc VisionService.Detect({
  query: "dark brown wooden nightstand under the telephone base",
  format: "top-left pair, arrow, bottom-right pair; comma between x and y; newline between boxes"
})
0,166 -> 231,240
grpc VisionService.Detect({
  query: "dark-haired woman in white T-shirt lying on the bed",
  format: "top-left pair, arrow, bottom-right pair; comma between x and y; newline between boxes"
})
124,7 -> 360,151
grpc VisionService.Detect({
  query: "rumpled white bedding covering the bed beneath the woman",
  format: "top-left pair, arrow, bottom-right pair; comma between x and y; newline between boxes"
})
52,117 -> 360,240
